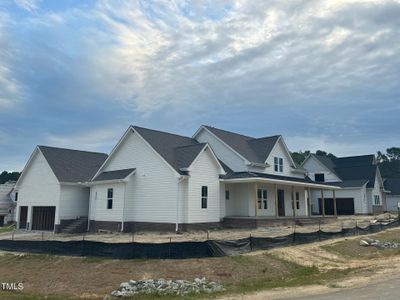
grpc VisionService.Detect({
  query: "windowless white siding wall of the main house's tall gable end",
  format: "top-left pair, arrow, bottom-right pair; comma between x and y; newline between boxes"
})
92,131 -> 182,223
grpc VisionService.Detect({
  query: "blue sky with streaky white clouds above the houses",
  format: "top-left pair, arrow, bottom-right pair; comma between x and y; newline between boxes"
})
0,0 -> 400,170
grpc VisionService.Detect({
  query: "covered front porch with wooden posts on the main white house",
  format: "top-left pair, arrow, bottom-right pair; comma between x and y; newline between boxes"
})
222,174 -> 340,223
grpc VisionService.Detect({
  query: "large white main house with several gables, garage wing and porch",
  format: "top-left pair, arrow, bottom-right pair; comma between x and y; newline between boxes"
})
17,126 -> 340,232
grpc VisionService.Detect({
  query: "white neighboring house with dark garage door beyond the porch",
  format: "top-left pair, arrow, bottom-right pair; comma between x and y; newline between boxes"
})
302,154 -> 386,215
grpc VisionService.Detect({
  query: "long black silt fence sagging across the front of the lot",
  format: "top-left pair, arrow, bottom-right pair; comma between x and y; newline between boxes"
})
0,221 -> 399,259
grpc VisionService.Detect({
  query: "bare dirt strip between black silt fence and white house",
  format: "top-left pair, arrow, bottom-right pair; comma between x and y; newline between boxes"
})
0,216 -> 384,243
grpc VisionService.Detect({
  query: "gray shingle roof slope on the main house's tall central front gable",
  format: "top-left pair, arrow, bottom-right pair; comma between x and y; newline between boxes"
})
132,126 -> 205,174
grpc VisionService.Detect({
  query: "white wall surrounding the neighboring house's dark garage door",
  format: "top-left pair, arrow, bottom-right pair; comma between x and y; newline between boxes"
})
311,187 -> 369,214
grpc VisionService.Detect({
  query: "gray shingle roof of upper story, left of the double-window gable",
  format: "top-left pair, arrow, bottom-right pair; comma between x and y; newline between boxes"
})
203,126 -> 280,163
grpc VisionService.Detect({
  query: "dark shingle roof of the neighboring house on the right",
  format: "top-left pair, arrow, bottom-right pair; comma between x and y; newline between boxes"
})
314,155 -> 378,188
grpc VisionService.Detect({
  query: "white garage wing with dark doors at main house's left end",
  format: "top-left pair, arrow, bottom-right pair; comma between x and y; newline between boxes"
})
16,146 -> 107,232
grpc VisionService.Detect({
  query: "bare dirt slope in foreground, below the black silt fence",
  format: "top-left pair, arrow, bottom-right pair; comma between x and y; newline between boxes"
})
0,229 -> 400,299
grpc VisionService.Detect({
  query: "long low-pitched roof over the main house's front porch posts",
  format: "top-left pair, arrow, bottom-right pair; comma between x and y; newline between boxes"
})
221,172 -> 341,190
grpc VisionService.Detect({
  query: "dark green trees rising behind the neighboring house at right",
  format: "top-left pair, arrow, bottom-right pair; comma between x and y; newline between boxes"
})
292,147 -> 400,178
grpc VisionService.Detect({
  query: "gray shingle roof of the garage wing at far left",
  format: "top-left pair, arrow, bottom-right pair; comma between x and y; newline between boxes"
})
38,146 -> 108,183
